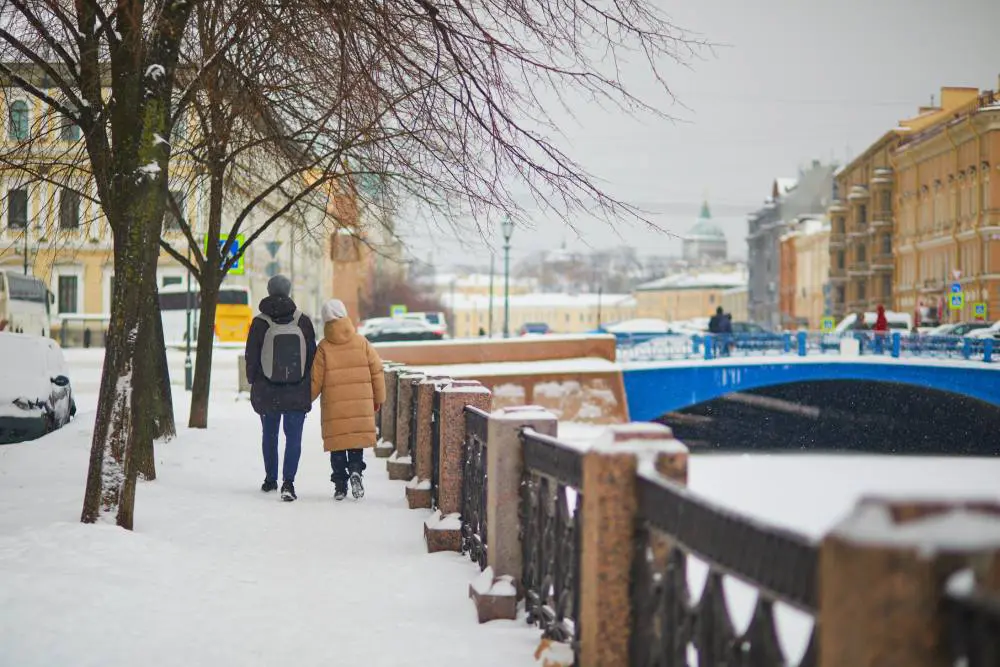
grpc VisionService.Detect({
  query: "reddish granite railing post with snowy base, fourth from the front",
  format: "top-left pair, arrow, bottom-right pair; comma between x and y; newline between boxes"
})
424,380 -> 493,552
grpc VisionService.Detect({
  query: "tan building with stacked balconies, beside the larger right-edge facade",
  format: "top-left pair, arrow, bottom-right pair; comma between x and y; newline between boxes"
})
828,88 -> 992,318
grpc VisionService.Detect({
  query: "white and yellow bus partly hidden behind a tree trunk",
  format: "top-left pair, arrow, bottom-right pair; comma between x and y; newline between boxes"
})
160,285 -> 254,347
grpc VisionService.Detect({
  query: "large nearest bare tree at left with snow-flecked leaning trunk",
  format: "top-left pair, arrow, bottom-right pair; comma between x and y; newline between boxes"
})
0,0 -> 196,528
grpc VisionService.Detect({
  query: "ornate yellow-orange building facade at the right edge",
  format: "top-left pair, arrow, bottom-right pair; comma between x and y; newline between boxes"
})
893,88 -> 1000,324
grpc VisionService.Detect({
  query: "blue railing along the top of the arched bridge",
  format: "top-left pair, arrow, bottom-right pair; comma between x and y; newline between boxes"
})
618,331 -> 998,363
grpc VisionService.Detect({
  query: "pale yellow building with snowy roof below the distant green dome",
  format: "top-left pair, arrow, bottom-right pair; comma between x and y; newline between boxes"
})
635,267 -> 747,322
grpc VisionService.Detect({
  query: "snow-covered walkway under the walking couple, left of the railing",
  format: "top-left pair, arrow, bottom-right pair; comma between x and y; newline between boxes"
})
0,350 -> 539,667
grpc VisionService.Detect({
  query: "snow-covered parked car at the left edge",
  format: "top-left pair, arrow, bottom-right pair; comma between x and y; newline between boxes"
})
0,333 -> 76,444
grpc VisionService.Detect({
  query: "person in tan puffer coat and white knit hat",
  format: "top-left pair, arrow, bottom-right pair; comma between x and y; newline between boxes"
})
312,299 -> 385,500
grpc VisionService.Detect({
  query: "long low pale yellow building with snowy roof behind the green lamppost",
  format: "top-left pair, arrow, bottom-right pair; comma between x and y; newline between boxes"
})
442,290 -> 636,338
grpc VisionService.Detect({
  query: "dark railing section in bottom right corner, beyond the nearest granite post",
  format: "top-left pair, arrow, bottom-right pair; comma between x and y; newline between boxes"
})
945,591 -> 1000,667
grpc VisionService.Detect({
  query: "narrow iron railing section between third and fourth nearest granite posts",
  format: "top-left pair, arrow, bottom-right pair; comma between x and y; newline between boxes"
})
462,406 -> 489,570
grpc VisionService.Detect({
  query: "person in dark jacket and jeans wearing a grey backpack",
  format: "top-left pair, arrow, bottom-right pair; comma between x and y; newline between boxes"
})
246,274 -> 316,501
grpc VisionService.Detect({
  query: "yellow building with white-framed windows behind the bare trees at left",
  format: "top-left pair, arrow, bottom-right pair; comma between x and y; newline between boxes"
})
0,64 -> 333,331
